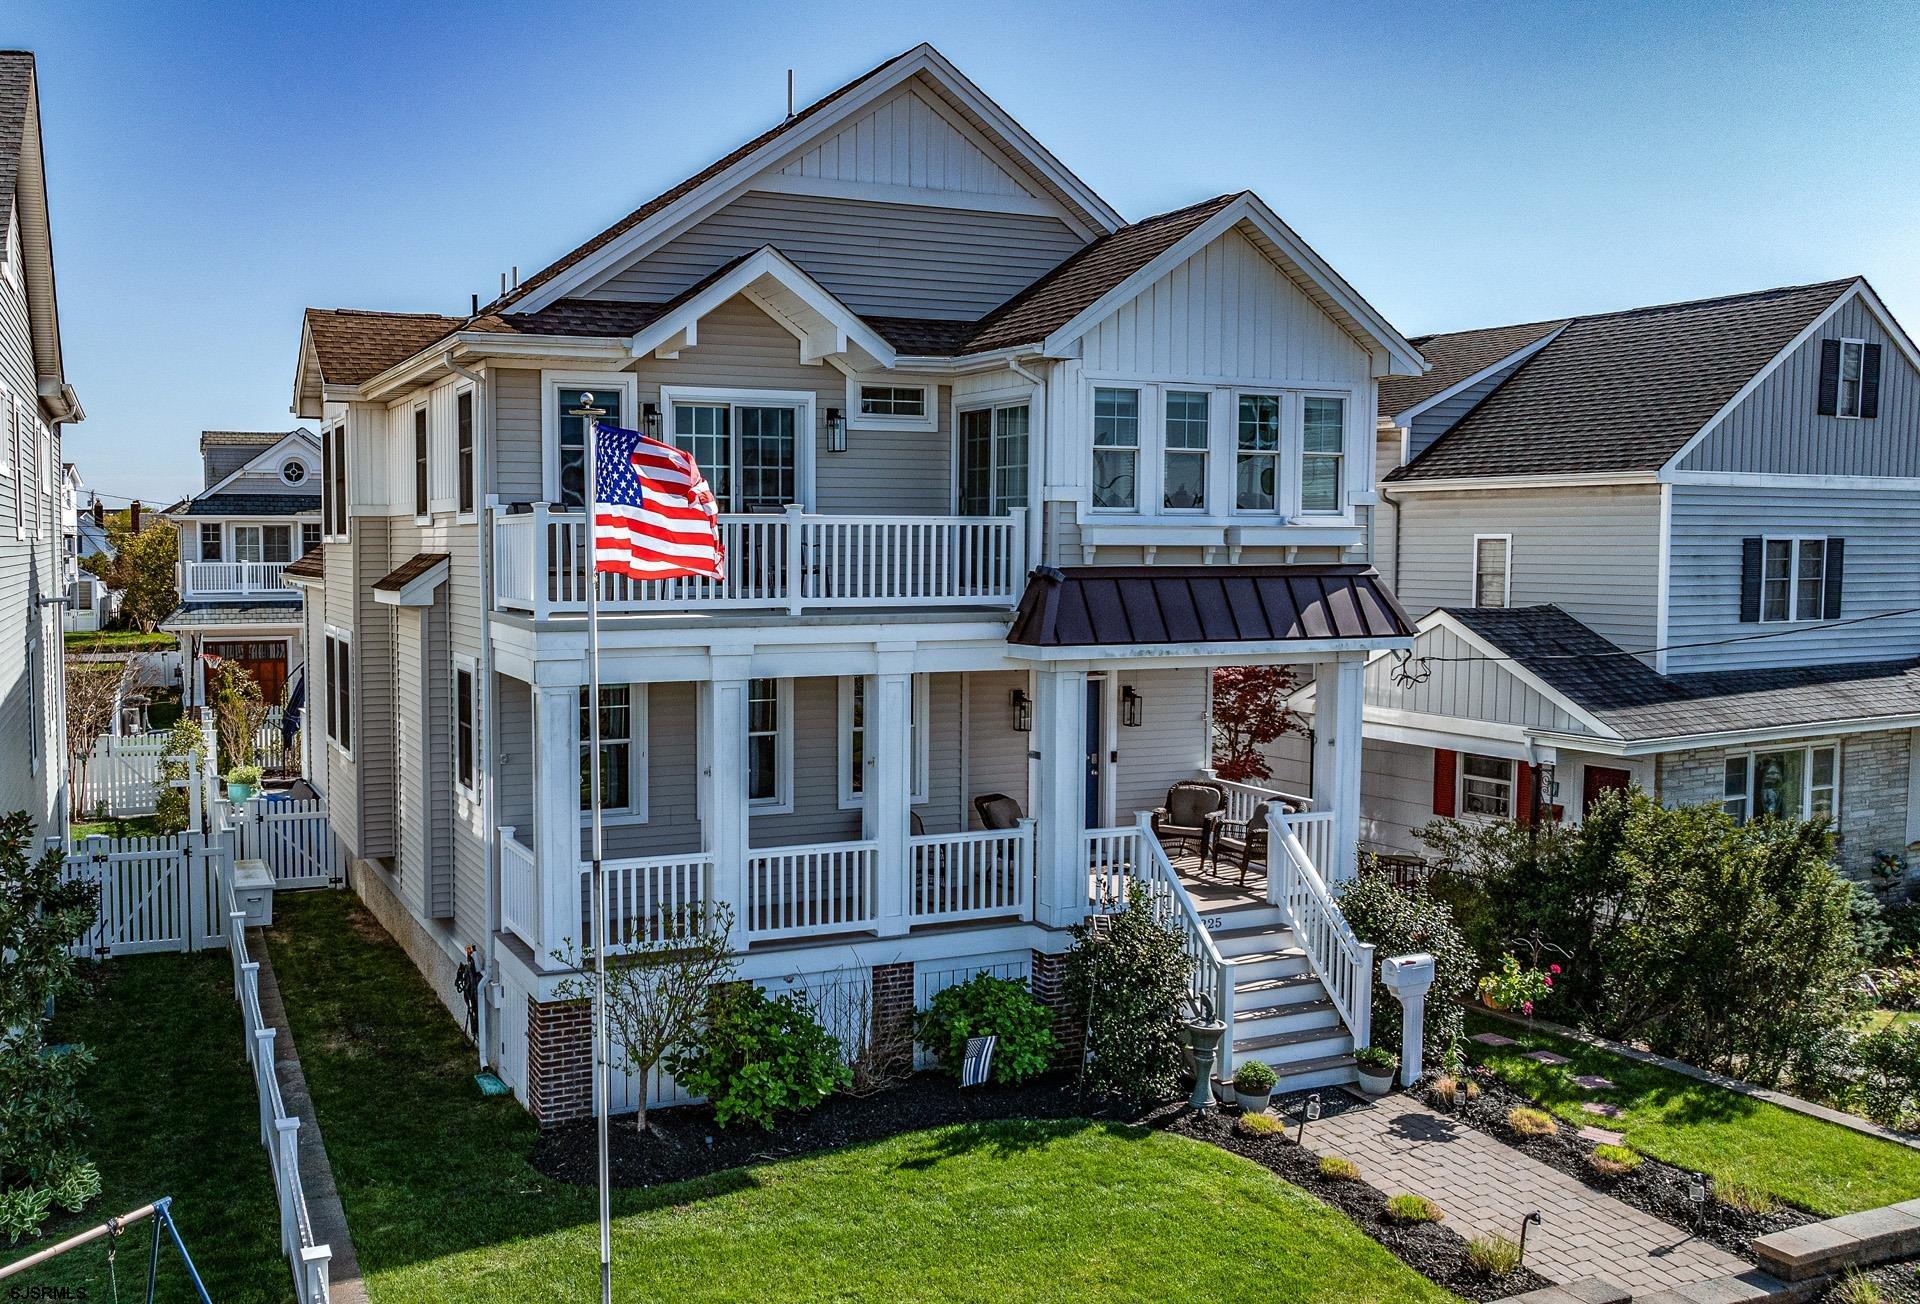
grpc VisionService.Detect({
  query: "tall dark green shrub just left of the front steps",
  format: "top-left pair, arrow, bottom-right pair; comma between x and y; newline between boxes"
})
1066,883 -> 1192,1100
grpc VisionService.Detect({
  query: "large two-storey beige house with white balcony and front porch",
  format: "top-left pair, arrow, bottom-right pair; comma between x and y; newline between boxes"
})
284,46 -> 1425,1120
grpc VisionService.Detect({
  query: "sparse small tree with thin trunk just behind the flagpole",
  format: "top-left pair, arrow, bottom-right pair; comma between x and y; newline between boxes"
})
555,903 -> 737,1131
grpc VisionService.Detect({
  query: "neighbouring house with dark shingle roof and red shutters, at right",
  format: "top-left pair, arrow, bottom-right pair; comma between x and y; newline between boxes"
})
1286,278 -> 1920,874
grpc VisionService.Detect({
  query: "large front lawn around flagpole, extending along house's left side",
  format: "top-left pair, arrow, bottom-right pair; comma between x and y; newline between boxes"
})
271,893 -> 1453,1304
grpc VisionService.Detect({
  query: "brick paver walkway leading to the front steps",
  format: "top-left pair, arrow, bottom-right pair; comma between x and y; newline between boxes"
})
1308,1095 -> 1753,1294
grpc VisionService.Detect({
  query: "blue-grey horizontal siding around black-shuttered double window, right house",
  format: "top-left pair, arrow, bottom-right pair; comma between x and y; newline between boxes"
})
1667,484 -> 1920,674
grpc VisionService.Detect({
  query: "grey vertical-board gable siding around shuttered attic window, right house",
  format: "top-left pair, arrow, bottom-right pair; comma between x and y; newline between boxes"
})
1680,296 -> 1920,478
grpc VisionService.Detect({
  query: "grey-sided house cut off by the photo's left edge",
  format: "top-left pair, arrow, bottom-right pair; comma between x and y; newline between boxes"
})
0,50 -> 83,839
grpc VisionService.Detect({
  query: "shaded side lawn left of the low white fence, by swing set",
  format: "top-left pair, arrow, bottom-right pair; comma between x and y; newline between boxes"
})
0,951 -> 292,1304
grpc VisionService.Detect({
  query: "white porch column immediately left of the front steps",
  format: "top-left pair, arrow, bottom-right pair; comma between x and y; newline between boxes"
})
1033,670 -> 1087,928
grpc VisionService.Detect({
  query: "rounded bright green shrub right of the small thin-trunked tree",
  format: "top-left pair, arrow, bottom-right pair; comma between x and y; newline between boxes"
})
672,983 -> 849,1129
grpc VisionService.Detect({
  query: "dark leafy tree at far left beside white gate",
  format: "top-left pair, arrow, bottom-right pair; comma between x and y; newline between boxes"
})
0,810 -> 100,1241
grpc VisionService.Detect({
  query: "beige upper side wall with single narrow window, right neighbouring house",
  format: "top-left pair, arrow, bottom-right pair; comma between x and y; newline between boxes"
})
1394,486 -> 1661,649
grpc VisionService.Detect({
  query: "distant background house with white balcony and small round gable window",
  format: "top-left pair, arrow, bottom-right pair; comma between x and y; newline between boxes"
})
161,426 -> 321,707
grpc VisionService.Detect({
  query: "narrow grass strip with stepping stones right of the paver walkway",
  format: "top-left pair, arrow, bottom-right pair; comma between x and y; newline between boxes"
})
1467,1014 -> 1920,1216
